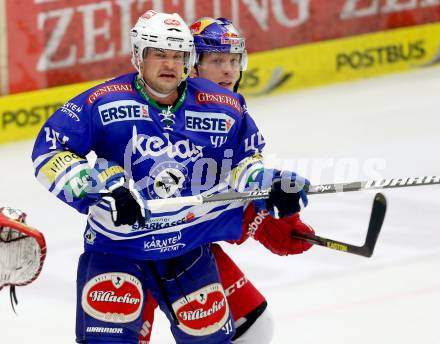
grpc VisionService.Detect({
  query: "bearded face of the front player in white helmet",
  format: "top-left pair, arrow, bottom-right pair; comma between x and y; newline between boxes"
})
142,48 -> 185,94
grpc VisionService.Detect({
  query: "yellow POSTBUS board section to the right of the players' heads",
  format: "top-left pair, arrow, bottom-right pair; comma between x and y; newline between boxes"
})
240,23 -> 440,96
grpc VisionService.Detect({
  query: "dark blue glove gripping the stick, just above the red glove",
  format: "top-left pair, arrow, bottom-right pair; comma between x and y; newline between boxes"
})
254,169 -> 310,218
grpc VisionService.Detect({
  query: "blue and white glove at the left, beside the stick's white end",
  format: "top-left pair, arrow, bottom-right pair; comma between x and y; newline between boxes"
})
88,159 -> 150,226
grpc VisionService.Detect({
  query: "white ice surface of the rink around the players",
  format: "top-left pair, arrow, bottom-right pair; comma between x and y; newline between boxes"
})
0,68 -> 440,344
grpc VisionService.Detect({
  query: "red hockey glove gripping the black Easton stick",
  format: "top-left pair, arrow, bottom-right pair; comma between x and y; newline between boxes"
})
237,203 -> 315,256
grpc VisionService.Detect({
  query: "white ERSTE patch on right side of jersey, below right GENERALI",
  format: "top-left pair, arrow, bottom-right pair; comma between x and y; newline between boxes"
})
185,111 -> 235,134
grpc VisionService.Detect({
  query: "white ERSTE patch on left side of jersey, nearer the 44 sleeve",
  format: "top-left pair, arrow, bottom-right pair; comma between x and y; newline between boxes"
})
98,100 -> 151,125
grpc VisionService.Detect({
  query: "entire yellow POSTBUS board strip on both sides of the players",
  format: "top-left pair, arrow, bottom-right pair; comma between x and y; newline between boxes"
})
0,23 -> 440,143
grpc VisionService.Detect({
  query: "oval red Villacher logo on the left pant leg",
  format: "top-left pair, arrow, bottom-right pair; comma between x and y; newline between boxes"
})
81,272 -> 143,323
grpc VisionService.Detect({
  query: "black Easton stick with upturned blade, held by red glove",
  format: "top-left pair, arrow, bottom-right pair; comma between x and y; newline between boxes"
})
291,193 -> 387,257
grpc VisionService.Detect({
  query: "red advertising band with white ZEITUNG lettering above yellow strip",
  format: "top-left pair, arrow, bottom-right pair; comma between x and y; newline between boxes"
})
0,0 -> 440,93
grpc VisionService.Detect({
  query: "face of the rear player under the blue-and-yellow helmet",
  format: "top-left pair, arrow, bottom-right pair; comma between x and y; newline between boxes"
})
197,53 -> 240,91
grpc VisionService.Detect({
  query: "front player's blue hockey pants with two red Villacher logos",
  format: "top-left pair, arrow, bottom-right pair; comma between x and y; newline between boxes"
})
76,245 -> 235,344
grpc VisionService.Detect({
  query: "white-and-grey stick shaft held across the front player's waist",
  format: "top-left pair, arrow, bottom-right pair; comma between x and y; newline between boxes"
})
147,176 -> 440,212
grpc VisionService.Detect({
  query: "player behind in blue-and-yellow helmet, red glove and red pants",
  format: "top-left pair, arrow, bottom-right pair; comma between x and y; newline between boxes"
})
140,17 -> 313,344
